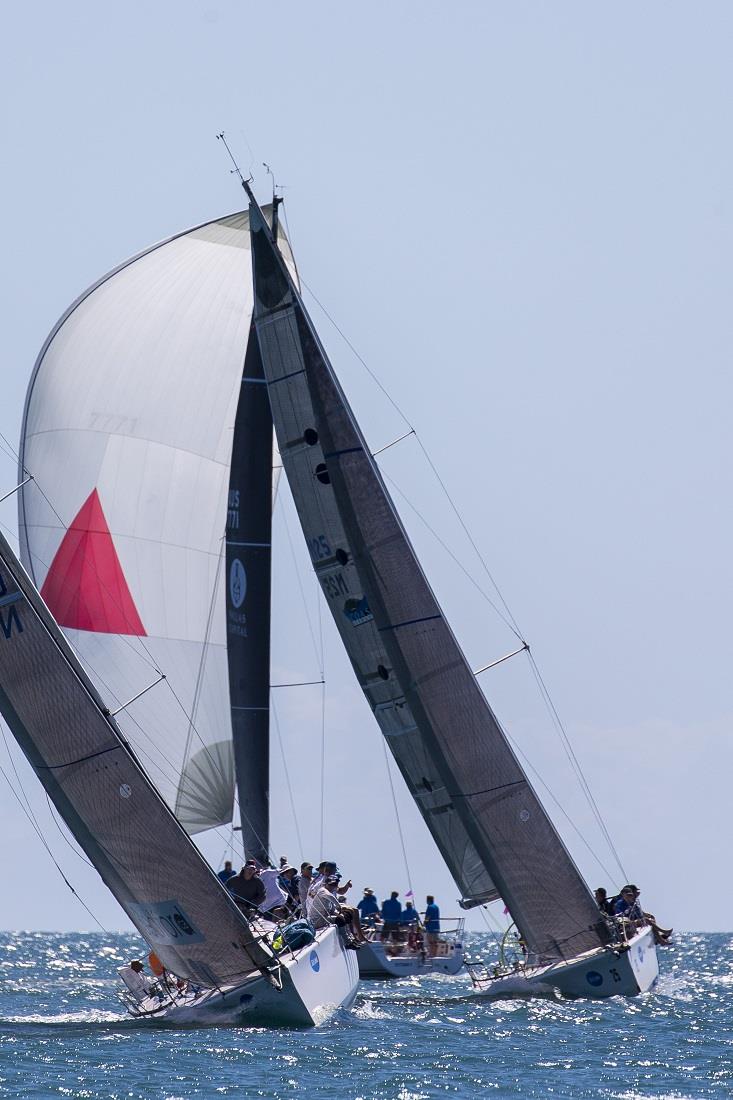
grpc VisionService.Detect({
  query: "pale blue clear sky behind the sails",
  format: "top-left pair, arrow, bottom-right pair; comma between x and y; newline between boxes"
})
0,0 -> 733,928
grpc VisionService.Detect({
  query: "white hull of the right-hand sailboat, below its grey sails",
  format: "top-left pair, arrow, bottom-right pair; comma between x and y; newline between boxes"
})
473,928 -> 659,999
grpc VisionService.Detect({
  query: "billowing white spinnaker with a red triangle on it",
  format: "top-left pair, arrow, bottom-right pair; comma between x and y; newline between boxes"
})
20,212 -> 290,833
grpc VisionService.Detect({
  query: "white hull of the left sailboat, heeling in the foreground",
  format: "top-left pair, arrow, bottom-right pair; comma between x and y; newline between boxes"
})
126,927 -> 359,1027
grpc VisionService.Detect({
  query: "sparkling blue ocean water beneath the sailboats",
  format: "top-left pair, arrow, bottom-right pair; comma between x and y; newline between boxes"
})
0,933 -> 733,1100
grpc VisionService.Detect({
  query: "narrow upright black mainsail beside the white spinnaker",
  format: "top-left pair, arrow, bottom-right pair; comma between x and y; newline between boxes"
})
227,327 -> 272,864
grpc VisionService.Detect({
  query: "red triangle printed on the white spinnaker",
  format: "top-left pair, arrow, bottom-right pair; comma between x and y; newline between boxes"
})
41,488 -> 145,636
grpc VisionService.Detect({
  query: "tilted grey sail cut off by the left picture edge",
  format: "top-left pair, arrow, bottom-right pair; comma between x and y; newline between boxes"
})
0,535 -> 272,987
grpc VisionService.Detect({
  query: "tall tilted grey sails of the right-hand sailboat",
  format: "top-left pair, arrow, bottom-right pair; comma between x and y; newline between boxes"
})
250,201 -> 608,958
